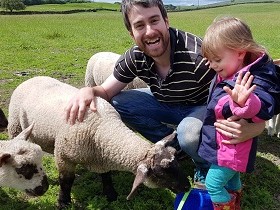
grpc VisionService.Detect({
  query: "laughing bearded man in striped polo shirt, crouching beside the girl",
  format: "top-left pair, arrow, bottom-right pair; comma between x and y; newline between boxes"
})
65,0 -> 264,184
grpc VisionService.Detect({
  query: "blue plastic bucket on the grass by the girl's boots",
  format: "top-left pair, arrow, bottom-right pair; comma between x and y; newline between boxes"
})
174,188 -> 214,210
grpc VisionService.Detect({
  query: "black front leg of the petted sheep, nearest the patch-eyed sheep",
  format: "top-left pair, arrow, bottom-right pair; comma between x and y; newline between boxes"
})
58,172 -> 75,209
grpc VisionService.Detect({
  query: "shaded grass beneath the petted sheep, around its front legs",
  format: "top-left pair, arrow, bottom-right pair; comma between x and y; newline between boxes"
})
69,161 -> 193,210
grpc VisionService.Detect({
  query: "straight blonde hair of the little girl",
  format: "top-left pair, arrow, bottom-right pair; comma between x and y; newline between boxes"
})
202,17 -> 267,62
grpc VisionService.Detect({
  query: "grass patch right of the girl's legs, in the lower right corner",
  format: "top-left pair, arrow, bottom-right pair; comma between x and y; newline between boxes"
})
242,131 -> 280,210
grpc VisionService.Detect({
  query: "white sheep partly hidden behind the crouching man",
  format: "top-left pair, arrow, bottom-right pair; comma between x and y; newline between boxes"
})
85,52 -> 148,89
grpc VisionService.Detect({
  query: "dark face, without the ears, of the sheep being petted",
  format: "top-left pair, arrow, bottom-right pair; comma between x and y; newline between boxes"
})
149,146 -> 190,193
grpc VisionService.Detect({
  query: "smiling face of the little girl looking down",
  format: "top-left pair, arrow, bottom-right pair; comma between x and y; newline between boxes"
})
208,47 -> 246,79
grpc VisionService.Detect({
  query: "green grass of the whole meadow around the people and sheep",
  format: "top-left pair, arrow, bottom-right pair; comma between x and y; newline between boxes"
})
0,3 -> 280,210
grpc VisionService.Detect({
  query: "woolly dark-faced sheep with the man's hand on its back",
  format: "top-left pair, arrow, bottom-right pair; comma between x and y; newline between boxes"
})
8,77 -> 190,208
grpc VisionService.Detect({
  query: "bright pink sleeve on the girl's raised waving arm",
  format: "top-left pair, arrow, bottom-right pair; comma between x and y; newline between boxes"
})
229,93 -> 261,118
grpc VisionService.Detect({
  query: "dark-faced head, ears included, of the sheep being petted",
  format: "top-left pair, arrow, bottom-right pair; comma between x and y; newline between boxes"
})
127,142 -> 190,200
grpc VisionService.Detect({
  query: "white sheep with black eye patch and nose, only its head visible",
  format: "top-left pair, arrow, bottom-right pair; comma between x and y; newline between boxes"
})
0,125 -> 49,196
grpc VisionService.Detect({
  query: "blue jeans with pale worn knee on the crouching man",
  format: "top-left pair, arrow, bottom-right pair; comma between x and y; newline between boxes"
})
111,88 -> 209,168
